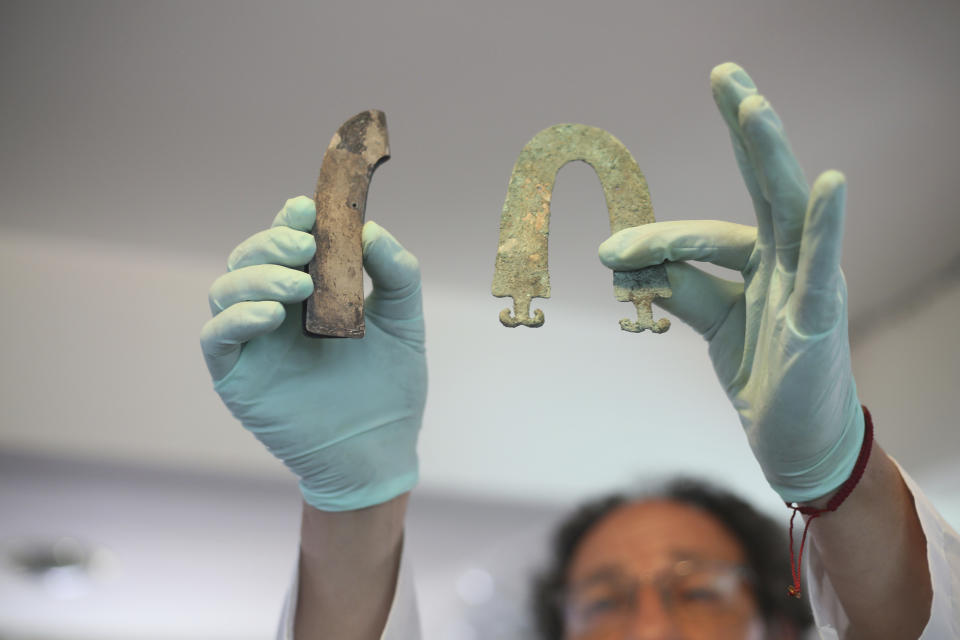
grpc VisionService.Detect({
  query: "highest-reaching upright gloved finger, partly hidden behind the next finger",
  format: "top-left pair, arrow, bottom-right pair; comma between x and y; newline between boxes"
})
710,62 -> 773,246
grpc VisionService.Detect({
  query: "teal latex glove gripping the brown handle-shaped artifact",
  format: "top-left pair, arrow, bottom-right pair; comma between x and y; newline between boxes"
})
200,196 -> 427,511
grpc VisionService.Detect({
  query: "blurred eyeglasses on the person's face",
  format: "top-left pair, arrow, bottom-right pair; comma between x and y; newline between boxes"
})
564,560 -> 752,639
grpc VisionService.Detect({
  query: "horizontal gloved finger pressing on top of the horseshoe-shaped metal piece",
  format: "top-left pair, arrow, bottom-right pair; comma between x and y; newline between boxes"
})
600,220 -> 757,271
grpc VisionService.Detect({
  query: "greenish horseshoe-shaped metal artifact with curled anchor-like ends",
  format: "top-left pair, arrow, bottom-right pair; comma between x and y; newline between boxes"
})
493,124 -> 672,333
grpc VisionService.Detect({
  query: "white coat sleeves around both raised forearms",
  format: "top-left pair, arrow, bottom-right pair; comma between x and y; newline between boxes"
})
277,469 -> 960,640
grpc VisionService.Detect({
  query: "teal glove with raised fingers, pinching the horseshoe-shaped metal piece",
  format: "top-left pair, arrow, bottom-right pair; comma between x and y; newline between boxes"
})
600,63 -> 864,502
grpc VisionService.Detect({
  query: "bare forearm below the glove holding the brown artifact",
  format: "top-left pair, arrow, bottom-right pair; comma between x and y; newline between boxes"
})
294,494 -> 409,640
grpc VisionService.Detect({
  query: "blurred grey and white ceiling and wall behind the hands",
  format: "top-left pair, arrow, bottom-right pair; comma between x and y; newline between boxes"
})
0,0 -> 960,640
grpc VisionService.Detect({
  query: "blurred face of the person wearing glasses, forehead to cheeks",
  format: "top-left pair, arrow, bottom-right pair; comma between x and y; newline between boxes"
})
564,500 -> 762,640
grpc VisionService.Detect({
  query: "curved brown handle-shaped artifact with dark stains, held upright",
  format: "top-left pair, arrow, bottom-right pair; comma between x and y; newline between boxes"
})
303,110 -> 390,338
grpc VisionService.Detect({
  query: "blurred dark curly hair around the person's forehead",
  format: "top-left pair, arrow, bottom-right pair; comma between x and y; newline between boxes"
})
532,478 -> 812,640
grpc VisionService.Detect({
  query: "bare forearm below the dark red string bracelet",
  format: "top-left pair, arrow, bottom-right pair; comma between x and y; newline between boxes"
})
810,442 -> 933,639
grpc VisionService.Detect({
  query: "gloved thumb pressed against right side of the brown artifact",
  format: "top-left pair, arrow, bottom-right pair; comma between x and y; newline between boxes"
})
362,222 -> 422,320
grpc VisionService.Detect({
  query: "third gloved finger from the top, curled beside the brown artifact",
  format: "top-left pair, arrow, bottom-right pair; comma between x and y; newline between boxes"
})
209,264 -> 313,316
